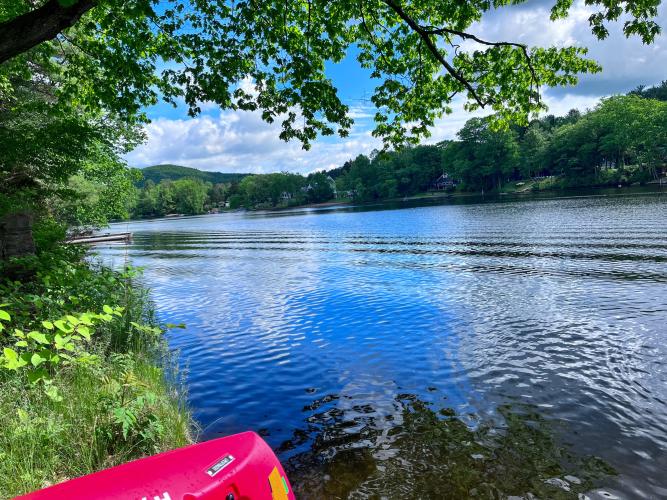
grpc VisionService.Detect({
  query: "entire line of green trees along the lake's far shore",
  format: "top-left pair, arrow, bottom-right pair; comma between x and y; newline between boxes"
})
133,81 -> 667,217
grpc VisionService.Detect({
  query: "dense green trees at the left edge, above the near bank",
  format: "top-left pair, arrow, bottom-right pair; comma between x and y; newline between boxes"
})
0,48 -> 143,225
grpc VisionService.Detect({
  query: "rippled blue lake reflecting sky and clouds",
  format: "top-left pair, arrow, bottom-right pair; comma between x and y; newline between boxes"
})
97,190 -> 667,498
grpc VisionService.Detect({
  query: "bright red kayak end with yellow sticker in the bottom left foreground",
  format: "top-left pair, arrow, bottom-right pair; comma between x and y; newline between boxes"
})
19,432 -> 294,500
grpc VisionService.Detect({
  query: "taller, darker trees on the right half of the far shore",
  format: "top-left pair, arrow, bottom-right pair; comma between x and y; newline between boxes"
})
329,81 -> 667,197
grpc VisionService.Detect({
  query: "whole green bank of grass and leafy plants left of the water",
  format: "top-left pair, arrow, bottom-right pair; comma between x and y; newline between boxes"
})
0,236 -> 191,498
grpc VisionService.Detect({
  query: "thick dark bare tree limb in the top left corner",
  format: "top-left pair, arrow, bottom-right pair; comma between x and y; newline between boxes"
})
0,0 -> 97,64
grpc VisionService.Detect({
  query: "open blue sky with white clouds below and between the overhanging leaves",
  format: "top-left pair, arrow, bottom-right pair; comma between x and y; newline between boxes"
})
127,0 -> 667,173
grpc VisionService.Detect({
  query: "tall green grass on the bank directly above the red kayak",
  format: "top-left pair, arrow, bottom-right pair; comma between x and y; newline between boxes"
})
0,353 -> 191,498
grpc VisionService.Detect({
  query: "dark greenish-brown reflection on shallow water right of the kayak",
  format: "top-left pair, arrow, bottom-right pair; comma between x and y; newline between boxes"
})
279,394 -> 615,499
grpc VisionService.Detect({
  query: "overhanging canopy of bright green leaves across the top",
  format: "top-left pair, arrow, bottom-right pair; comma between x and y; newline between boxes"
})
0,0 -> 660,147
